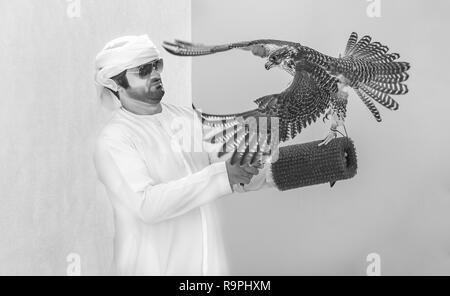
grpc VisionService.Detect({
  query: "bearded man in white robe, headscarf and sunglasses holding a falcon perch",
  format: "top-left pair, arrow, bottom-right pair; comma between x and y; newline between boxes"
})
94,35 -> 271,275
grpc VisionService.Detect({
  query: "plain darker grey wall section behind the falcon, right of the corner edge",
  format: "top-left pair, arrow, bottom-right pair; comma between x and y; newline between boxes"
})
192,0 -> 450,275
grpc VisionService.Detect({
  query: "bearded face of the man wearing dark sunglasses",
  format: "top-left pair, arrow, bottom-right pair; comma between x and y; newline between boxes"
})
125,60 -> 165,104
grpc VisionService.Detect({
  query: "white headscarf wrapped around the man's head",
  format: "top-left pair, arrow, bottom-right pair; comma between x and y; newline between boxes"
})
95,35 -> 160,106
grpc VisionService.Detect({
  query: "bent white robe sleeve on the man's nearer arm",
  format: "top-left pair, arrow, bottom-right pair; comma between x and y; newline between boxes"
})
94,136 -> 232,224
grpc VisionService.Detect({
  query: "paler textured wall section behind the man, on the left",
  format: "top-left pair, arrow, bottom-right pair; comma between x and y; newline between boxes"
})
0,0 -> 191,275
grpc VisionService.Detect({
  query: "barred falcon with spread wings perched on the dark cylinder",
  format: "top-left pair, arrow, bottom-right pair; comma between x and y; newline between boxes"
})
163,32 -> 410,165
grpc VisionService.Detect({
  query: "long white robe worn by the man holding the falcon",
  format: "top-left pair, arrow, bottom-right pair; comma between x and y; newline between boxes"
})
94,103 -> 273,275
